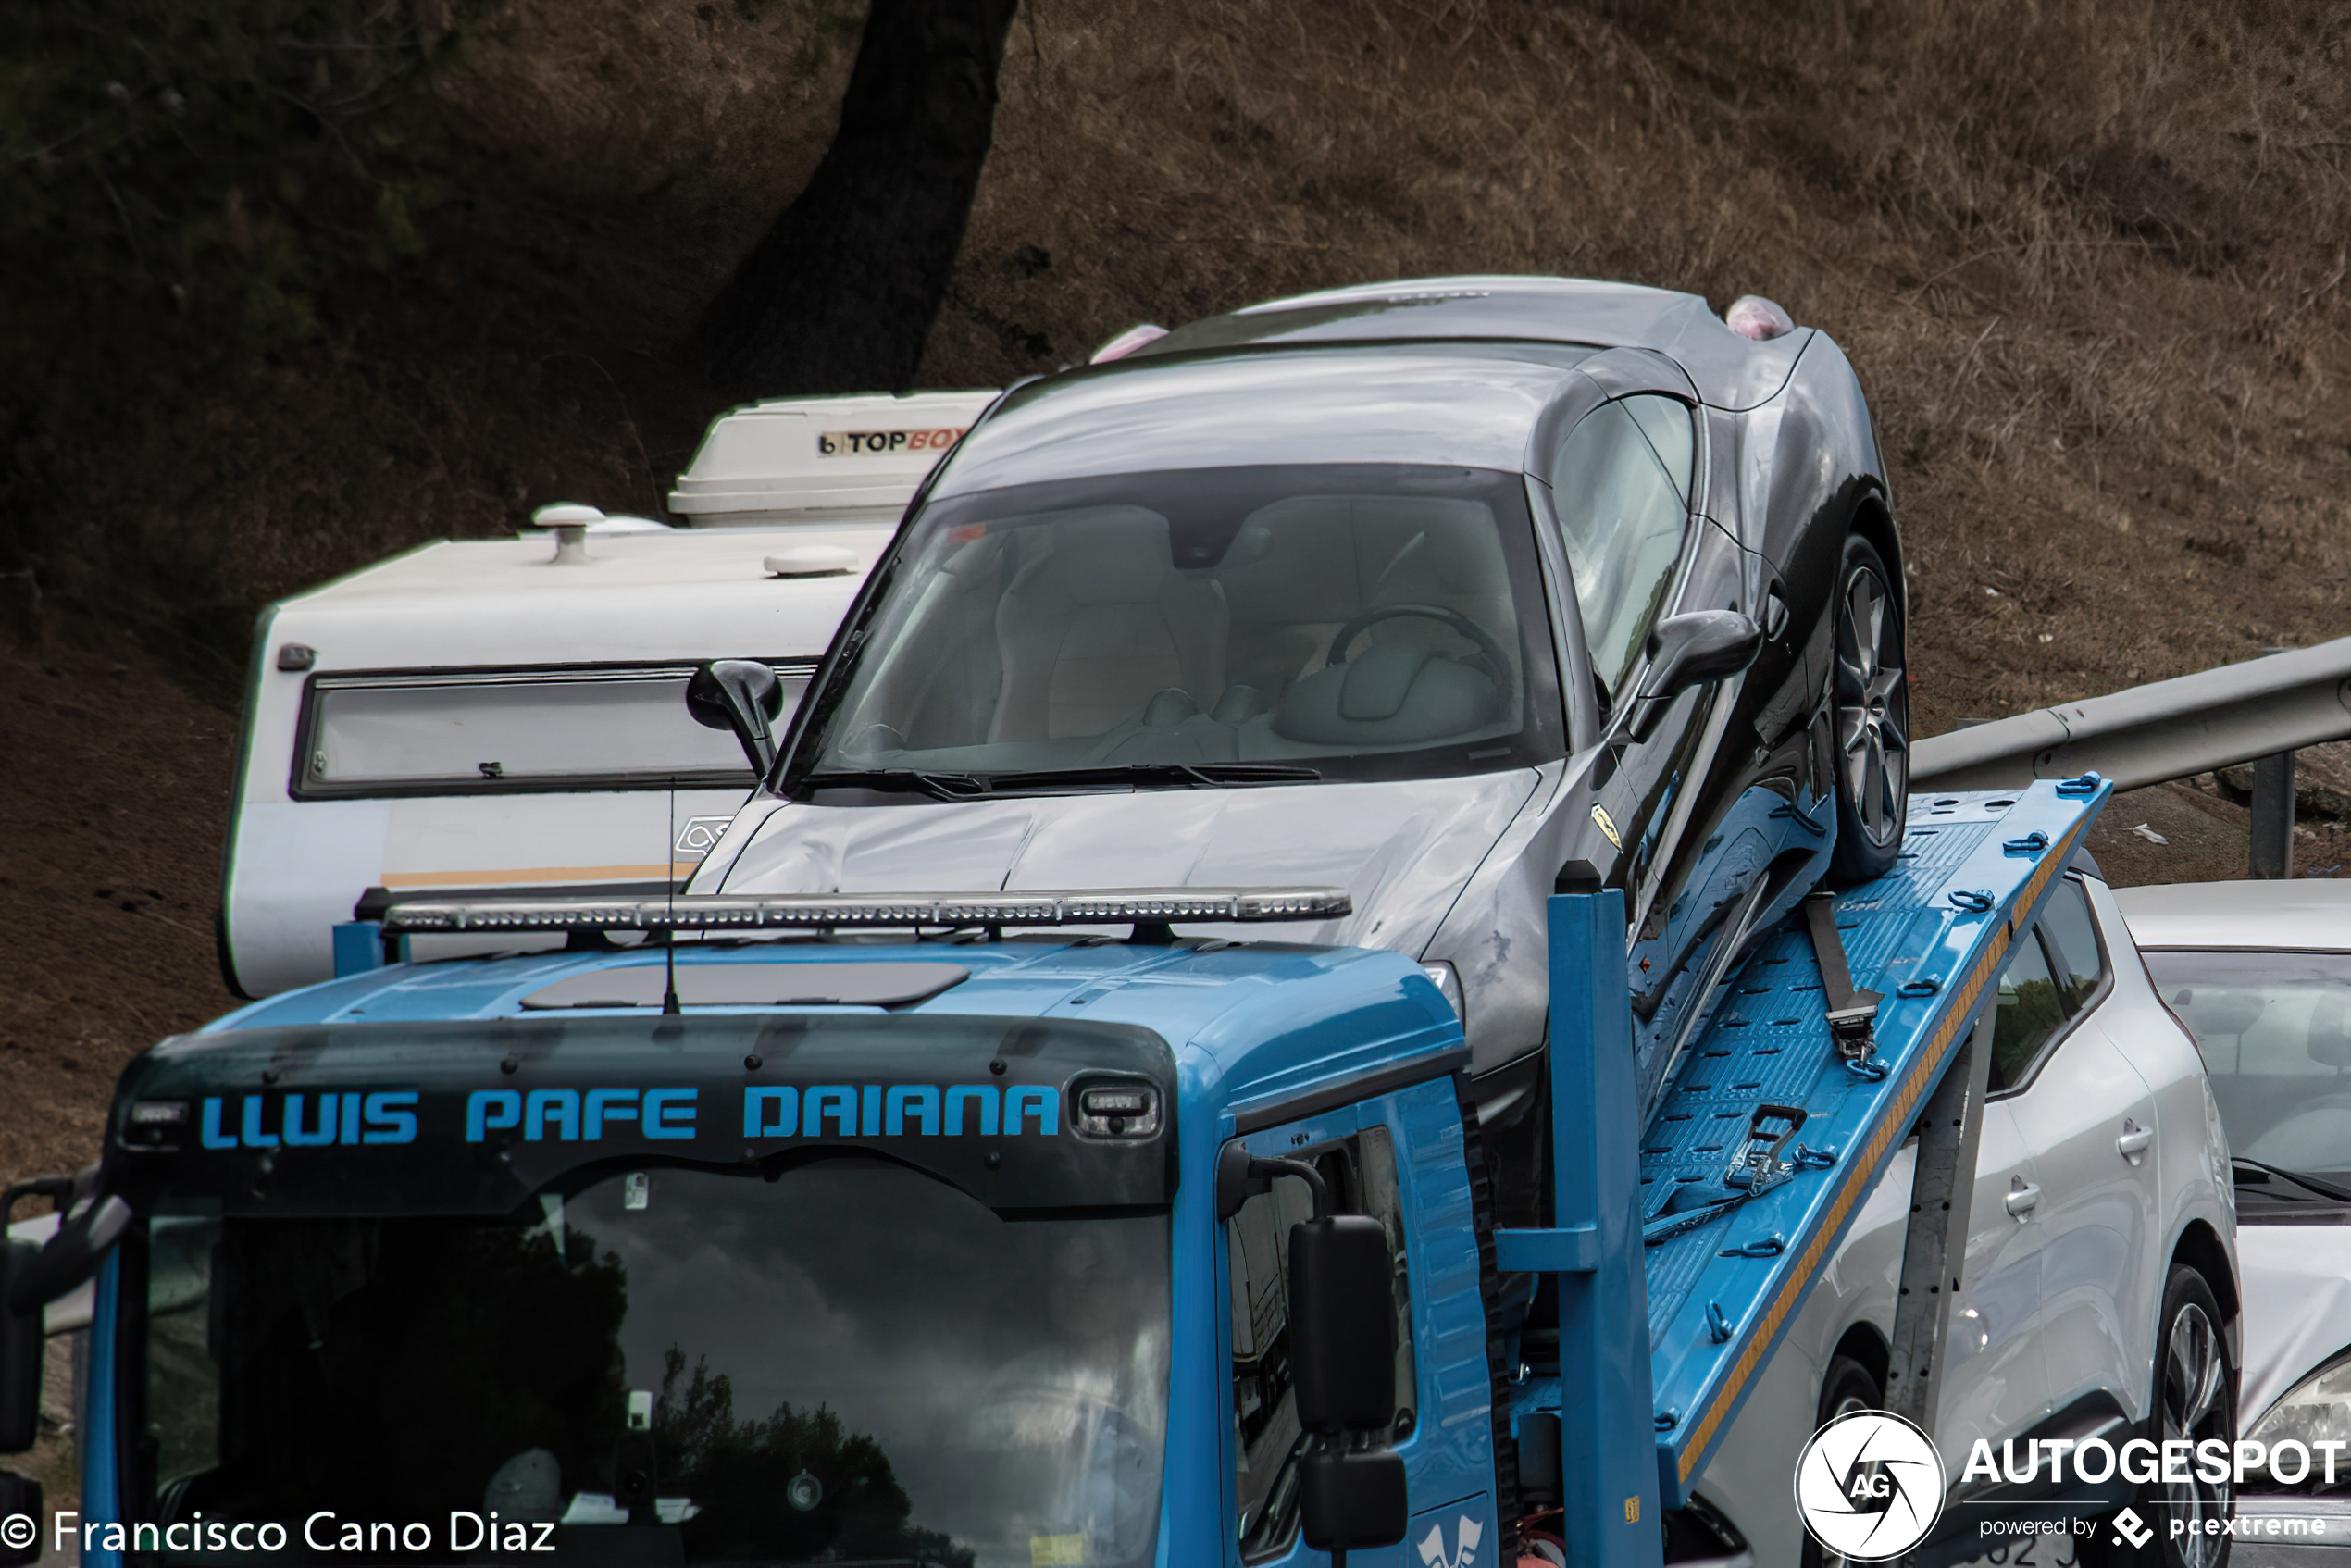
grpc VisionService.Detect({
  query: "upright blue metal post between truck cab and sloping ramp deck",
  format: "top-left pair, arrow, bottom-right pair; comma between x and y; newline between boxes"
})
1549,889 -> 1664,1568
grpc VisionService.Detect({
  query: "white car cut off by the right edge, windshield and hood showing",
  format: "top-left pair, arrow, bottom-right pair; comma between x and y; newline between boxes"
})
2119,881 -> 2351,1512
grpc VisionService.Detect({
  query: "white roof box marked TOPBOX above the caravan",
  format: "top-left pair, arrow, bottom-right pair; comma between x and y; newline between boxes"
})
670,392 -> 997,527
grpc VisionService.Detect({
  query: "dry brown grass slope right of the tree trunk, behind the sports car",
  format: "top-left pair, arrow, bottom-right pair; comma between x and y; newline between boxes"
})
928,0 -> 2351,724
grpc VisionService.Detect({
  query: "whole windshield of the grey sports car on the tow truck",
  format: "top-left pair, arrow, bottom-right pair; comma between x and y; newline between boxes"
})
792,463 -> 1561,794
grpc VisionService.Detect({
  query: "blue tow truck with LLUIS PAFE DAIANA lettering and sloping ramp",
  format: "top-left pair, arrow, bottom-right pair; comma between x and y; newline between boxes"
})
0,776 -> 2107,1568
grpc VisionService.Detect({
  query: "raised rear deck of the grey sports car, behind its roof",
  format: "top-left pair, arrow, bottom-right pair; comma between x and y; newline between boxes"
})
1136,275 -> 1815,409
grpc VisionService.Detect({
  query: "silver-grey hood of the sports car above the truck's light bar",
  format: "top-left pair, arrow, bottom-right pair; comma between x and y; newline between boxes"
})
696,768 -> 1542,954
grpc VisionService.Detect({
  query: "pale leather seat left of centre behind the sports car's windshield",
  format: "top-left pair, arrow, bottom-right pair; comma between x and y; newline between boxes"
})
988,505 -> 1227,740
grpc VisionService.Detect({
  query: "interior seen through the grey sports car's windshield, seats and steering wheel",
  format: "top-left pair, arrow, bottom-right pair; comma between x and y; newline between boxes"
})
826,492 -> 1542,771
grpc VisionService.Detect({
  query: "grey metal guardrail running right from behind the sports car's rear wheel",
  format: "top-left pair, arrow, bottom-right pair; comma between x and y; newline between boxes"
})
1911,637 -> 2351,790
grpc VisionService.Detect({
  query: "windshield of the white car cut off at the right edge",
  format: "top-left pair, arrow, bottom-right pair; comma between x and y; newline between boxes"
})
2146,948 -> 2351,1185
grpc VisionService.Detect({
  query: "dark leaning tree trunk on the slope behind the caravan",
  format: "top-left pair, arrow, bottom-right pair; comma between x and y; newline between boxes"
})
698,0 -> 1018,397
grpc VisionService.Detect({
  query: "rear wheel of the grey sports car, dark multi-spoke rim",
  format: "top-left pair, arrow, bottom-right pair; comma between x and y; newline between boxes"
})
1829,534 -> 1909,886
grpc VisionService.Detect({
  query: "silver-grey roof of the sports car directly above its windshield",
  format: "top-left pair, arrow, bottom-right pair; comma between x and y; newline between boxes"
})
936,343 -> 1589,496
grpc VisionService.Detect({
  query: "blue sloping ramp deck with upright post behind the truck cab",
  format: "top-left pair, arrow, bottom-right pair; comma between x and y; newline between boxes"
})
1495,774 -> 2108,1568
